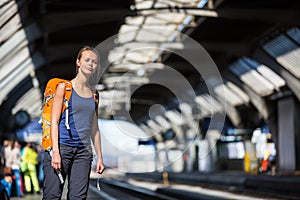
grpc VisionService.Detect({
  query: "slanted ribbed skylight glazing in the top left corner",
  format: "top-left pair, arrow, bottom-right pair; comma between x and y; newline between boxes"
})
0,1 -> 39,108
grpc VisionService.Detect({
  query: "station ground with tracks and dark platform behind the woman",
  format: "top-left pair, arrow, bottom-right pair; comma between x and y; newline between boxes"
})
11,172 -> 300,200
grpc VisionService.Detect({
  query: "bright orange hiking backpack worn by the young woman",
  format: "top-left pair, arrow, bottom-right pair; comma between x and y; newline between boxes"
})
41,78 -> 99,150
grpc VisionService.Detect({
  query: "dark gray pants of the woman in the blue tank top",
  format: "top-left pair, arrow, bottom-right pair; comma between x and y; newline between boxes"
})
43,145 -> 92,200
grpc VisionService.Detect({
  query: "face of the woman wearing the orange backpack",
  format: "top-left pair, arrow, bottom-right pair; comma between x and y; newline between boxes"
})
77,50 -> 98,76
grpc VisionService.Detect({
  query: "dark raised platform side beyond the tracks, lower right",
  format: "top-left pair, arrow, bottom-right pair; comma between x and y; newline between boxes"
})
126,172 -> 300,199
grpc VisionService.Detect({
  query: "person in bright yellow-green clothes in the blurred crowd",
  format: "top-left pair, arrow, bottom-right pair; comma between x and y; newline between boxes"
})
22,143 -> 40,194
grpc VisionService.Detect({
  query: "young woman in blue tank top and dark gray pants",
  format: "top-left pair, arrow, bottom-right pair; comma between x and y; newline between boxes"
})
43,46 -> 104,200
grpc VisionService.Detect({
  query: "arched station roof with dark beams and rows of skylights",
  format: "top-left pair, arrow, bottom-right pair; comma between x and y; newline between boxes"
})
0,0 -> 300,132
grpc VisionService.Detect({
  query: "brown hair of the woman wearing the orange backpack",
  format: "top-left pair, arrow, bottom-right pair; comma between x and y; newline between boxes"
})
76,46 -> 101,86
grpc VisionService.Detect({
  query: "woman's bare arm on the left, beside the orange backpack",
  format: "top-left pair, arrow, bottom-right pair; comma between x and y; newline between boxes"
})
50,83 -> 65,170
